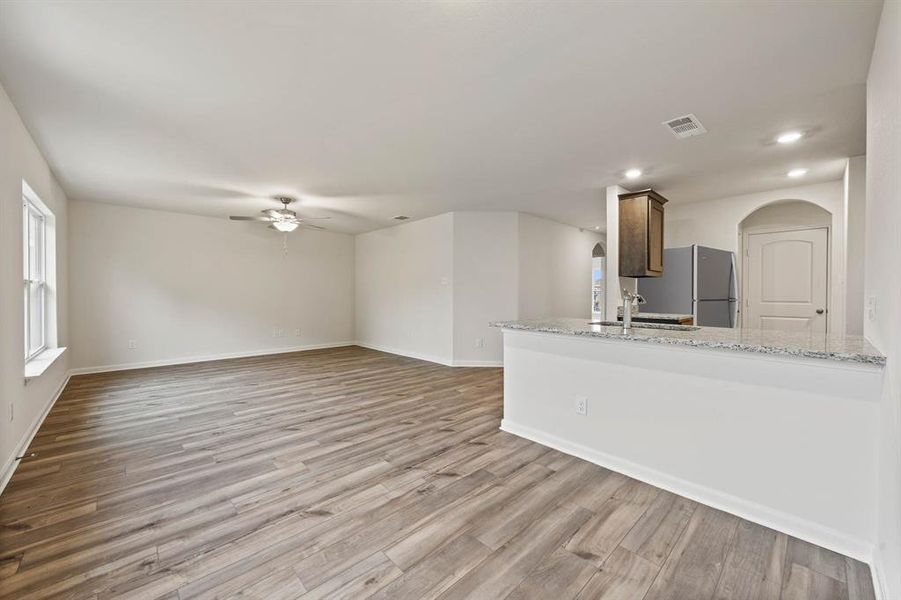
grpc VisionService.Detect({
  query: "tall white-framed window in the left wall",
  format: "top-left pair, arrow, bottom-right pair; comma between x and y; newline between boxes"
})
22,185 -> 48,362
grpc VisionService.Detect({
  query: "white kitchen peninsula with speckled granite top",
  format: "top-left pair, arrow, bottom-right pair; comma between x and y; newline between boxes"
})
493,319 -> 885,559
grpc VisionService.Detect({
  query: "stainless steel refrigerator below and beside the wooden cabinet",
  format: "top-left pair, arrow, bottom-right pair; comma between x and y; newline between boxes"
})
638,245 -> 738,327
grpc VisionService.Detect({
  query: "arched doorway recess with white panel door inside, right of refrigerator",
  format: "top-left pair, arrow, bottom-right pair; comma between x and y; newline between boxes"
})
739,200 -> 832,333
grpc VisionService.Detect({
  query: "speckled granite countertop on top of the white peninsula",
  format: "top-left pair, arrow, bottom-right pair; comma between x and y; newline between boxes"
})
491,318 -> 885,365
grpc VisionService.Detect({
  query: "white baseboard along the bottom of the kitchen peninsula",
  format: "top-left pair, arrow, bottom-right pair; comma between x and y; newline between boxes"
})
501,419 -> 878,571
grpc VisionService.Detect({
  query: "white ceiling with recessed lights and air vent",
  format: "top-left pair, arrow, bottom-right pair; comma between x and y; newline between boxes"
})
0,1 -> 881,232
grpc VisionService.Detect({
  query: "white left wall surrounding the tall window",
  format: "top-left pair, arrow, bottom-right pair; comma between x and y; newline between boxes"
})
0,83 -> 69,487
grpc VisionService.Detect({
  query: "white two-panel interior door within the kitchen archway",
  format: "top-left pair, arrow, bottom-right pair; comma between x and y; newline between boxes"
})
744,228 -> 829,333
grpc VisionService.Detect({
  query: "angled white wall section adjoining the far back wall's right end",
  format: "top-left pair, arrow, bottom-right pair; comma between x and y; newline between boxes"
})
354,213 -> 454,364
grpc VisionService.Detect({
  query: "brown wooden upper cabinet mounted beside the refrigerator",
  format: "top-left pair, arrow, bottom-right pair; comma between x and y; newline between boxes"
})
619,190 -> 666,277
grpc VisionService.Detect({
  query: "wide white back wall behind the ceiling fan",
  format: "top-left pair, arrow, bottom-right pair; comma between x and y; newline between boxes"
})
69,202 -> 354,369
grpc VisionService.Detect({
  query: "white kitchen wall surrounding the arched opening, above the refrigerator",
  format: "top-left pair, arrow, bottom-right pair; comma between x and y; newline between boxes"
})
664,180 -> 845,331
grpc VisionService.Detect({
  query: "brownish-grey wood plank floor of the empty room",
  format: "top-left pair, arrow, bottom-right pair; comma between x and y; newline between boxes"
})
0,347 -> 873,600
